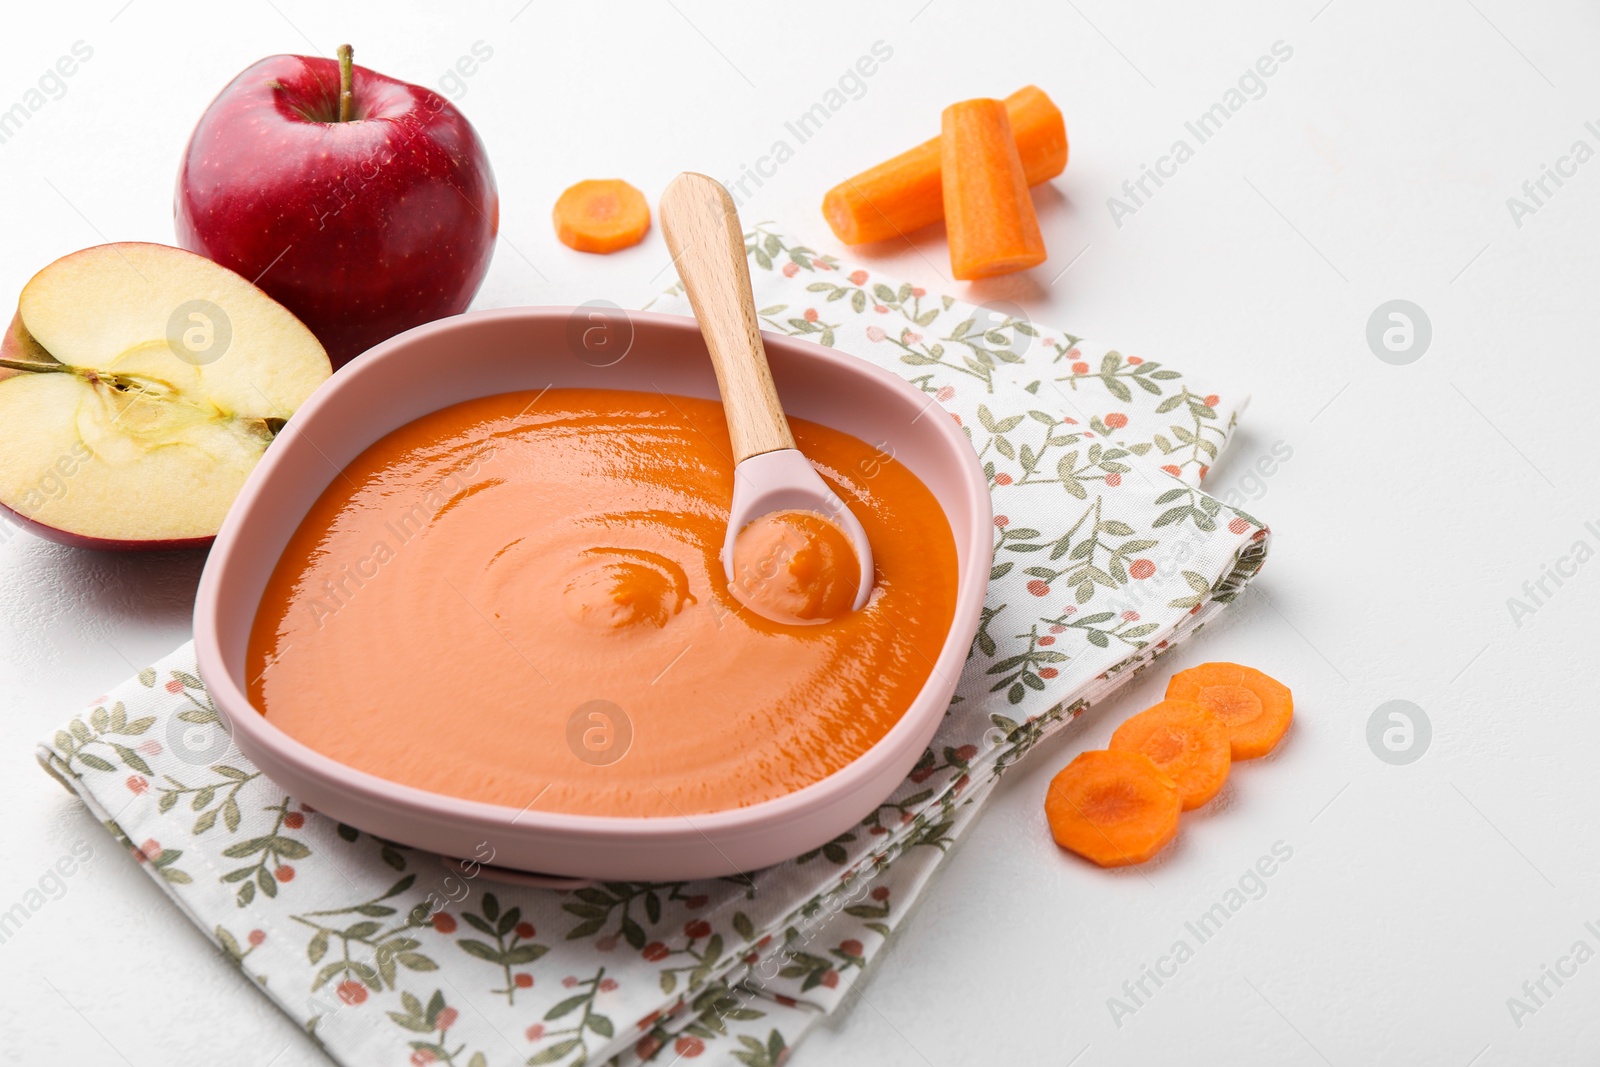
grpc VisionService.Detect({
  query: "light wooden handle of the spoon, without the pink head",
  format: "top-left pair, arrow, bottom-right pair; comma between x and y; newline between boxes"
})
661,171 -> 795,464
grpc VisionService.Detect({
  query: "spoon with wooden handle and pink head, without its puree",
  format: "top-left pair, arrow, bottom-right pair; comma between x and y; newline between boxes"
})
661,171 -> 872,621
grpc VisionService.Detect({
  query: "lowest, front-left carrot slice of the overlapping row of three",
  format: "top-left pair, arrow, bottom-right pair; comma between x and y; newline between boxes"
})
1045,750 -> 1181,867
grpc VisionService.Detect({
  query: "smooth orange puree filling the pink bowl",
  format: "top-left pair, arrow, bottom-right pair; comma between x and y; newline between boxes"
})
248,389 -> 955,816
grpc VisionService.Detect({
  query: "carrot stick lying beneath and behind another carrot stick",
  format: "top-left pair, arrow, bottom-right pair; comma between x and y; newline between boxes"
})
822,85 -> 1067,245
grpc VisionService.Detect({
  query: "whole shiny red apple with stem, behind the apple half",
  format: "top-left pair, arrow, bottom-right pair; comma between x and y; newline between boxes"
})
174,56 -> 499,368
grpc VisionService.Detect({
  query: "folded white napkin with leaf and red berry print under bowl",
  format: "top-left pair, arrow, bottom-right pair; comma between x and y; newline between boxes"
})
38,226 -> 1267,1067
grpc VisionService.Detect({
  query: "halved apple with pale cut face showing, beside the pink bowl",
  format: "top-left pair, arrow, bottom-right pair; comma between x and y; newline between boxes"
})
0,243 -> 333,549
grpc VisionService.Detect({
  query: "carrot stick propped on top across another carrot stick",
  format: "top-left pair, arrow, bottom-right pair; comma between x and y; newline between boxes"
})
939,99 -> 1045,282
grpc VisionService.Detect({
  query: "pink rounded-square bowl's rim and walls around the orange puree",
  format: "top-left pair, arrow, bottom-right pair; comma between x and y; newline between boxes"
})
195,307 -> 994,881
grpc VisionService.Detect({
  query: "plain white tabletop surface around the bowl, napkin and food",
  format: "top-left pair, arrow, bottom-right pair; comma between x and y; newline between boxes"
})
0,0 -> 1600,1067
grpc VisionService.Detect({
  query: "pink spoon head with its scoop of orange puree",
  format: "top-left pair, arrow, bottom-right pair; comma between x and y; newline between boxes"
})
722,448 -> 872,625
